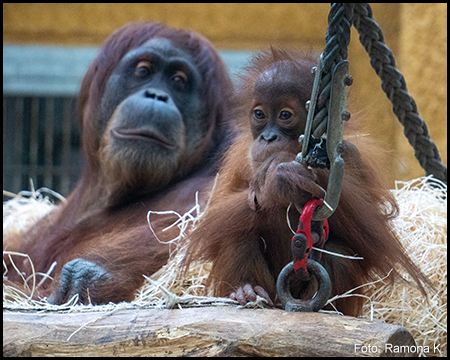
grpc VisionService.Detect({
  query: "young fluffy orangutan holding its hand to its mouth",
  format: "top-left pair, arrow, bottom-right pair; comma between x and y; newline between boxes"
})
187,49 -> 429,315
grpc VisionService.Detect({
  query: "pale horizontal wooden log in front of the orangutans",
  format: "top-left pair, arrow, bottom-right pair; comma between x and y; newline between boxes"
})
3,307 -> 416,356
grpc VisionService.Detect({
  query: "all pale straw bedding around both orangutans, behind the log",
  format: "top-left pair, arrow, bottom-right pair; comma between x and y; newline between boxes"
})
3,177 -> 447,356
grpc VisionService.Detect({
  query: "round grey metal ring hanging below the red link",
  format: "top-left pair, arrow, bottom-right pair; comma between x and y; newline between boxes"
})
277,259 -> 331,312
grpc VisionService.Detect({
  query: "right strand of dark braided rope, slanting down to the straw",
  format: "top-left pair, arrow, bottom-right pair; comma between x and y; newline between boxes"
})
354,3 -> 447,183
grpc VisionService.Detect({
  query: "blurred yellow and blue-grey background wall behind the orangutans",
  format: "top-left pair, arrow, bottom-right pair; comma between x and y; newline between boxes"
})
3,3 -> 447,195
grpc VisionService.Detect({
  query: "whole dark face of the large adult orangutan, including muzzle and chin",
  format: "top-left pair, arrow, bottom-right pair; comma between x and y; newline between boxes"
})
99,38 -> 205,197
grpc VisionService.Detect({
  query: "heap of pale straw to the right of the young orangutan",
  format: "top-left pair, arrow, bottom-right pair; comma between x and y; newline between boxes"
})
358,178 -> 447,356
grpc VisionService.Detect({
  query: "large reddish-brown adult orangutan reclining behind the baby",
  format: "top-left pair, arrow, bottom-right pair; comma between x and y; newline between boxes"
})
3,22 -> 232,304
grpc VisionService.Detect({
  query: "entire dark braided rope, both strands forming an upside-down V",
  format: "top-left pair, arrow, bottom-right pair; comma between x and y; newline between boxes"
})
308,3 -> 447,183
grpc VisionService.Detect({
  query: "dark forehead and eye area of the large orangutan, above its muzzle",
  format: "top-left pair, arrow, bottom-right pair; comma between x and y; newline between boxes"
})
99,38 -> 201,133
